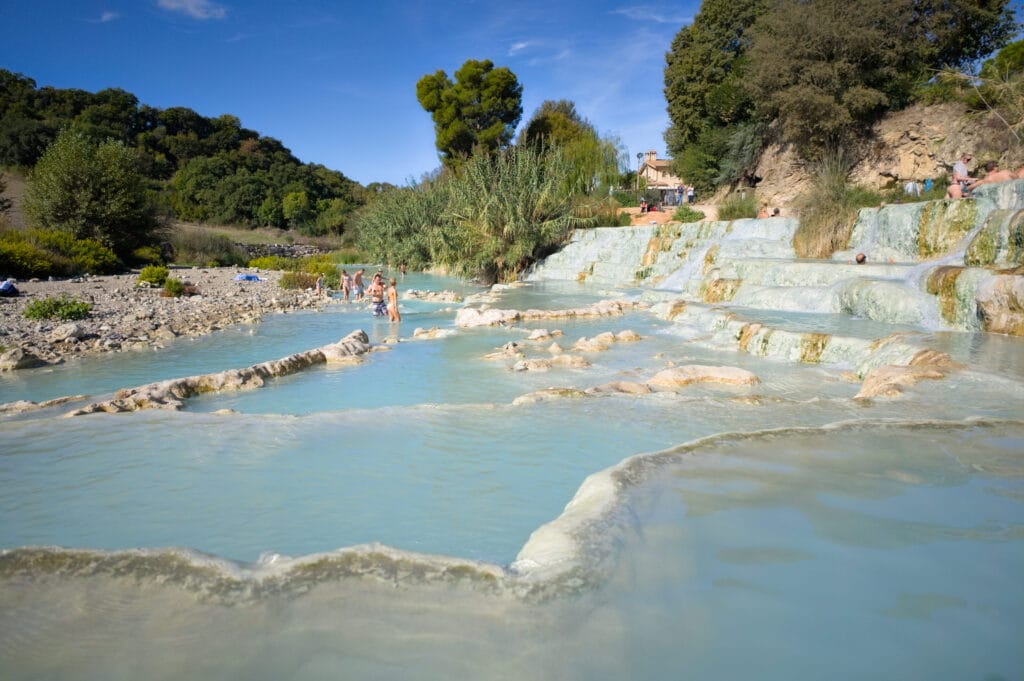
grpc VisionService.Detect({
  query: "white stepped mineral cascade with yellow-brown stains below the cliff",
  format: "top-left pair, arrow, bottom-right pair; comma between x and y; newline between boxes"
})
527,180 -> 1024,337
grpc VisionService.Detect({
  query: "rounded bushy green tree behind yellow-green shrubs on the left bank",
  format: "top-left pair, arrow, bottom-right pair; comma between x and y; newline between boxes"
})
25,129 -> 157,258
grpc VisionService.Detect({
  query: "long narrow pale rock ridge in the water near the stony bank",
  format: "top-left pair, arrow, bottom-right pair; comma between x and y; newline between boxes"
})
67,331 -> 370,416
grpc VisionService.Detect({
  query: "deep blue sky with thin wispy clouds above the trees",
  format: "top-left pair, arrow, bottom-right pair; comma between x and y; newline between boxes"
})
0,0 -> 699,184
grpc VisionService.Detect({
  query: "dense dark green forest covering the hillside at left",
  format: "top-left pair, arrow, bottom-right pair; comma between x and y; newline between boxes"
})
0,69 -> 366,233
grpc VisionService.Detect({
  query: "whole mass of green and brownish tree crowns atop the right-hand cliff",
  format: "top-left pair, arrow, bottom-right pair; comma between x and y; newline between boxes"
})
665,0 -> 1017,183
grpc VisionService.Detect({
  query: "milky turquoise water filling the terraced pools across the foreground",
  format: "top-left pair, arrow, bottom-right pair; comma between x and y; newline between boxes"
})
0,275 -> 1024,679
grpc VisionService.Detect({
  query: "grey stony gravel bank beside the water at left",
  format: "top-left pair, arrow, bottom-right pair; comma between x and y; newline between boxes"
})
0,267 -> 330,371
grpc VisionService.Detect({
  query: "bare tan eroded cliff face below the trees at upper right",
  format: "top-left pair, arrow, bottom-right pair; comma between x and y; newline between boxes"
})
757,103 -> 1021,210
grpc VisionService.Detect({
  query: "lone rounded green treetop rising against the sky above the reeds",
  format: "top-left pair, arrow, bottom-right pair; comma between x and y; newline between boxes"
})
416,59 -> 522,165
